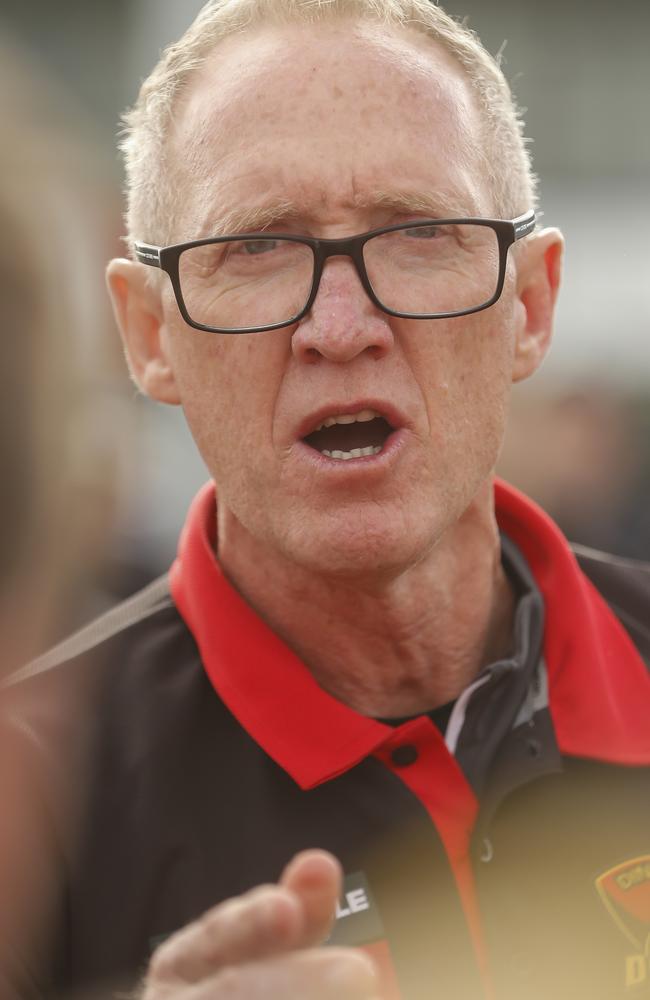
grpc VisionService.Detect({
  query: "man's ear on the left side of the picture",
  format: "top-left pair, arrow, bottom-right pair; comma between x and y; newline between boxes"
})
106,258 -> 180,405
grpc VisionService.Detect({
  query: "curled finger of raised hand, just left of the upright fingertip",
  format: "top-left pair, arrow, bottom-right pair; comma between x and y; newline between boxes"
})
147,885 -> 304,984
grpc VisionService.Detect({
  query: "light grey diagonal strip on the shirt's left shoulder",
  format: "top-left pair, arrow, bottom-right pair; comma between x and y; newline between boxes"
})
0,573 -> 174,690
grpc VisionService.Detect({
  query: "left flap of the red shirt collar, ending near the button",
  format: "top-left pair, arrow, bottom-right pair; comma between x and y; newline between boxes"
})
170,483 -> 393,788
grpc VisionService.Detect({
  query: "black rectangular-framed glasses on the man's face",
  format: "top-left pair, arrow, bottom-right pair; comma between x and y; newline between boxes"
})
135,210 -> 535,333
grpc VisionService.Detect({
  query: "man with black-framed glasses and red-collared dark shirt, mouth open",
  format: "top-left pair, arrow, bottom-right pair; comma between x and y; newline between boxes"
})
2,0 -> 650,1000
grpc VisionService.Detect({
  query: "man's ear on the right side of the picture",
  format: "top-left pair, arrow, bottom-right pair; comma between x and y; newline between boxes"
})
512,229 -> 564,382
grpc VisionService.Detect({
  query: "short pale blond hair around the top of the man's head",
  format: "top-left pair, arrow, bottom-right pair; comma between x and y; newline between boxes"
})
121,0 -> 536,244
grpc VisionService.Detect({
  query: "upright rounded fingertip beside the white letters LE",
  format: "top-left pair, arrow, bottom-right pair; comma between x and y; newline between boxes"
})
280,850 -> 343,947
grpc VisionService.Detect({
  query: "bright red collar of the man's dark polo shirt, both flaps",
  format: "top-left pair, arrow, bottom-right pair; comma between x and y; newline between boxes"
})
170,481 -> 650,788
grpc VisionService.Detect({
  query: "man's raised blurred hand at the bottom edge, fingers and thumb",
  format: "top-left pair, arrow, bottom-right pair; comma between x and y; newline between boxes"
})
142,850 -> 379,1000
